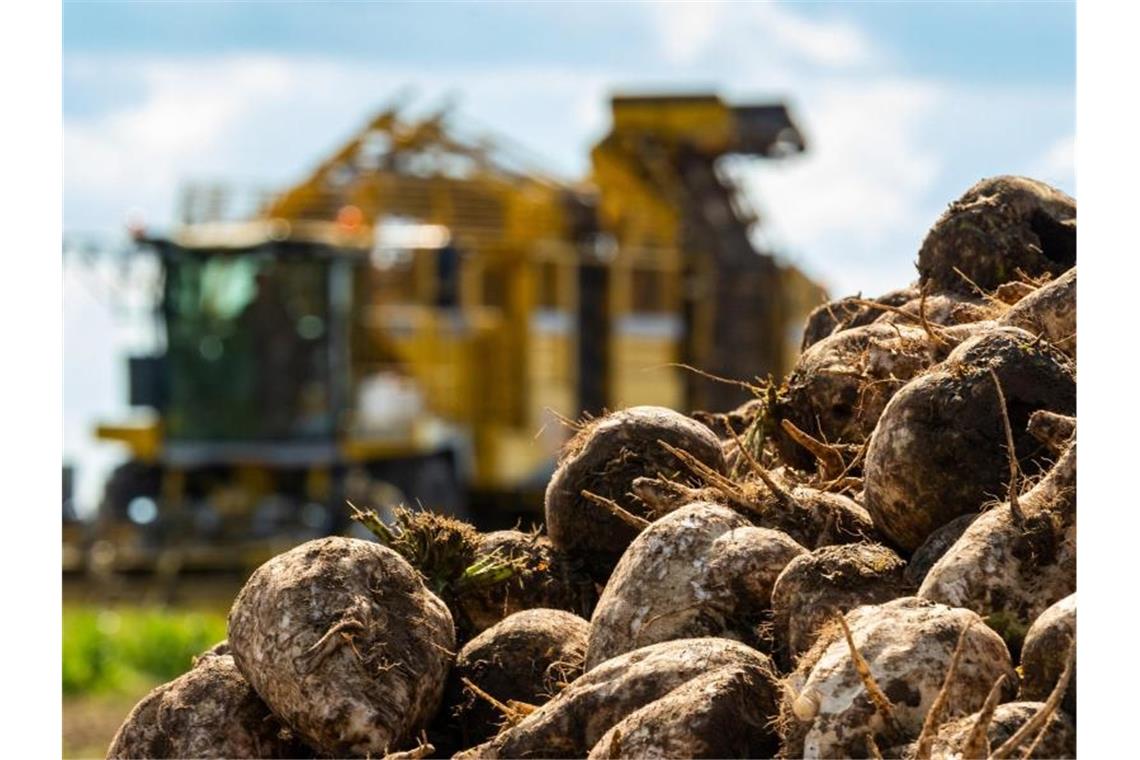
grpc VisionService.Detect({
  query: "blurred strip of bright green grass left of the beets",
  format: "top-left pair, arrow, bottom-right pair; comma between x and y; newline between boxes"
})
63,606 -> 226,695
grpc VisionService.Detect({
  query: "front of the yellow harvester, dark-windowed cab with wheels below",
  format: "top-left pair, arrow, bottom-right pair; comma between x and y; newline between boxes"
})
97,221 -> 465,570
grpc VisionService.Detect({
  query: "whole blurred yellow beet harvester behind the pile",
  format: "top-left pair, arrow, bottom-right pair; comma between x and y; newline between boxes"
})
86,96 -> 824,569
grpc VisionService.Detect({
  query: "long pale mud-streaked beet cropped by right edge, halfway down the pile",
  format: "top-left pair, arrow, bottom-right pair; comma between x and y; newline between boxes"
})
918,442 -> 1076,653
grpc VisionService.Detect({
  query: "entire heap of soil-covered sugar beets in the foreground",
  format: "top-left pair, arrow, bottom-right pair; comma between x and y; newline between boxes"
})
109,177 -> 1076,758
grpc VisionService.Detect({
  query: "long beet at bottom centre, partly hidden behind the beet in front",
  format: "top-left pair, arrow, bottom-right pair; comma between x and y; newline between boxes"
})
456,638 -> 779,759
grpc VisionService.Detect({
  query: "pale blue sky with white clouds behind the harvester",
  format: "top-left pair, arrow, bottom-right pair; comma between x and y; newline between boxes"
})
63,1 -> 1076,517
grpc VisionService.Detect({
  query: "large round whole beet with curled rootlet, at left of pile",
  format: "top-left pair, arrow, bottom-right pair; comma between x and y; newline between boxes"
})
228,537 -> 455,757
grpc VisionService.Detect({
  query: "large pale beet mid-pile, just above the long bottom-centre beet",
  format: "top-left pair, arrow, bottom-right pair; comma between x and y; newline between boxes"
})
586,502 -> 806,669
